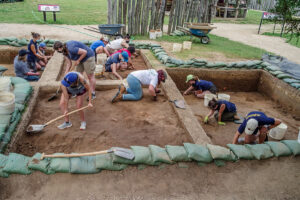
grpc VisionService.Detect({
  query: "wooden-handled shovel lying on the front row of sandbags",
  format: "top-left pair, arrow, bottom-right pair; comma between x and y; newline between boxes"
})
41,147 -> 134,160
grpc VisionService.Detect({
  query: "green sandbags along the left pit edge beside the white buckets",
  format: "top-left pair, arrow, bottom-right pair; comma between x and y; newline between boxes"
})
0,77 -> 32,152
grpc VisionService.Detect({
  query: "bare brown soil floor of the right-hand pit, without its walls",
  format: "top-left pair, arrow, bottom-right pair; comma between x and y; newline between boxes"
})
185,92 -> 300,146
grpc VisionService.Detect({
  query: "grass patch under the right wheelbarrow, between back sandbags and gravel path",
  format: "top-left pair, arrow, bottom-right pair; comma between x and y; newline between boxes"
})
134,34 -> 267,60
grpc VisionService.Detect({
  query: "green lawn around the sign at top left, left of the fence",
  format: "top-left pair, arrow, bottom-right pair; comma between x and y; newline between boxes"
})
0,0 -> 107,25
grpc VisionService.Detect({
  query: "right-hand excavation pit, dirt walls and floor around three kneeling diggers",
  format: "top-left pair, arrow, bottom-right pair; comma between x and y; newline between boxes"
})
167,68 -> 300,146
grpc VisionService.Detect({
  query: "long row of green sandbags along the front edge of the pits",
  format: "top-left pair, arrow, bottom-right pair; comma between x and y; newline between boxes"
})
0,140 -> 300,177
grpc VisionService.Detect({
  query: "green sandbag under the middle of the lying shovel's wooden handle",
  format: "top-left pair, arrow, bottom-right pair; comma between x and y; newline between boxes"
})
70,156 -> 100,174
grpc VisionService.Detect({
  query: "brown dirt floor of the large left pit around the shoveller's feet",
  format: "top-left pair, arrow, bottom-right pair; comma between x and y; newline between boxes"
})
12,90 -> 189,156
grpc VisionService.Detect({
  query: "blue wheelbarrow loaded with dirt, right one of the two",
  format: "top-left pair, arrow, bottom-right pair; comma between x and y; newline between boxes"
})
177,23 -> 216,44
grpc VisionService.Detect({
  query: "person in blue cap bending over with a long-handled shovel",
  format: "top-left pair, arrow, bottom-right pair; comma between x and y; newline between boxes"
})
57,72 -> 93,130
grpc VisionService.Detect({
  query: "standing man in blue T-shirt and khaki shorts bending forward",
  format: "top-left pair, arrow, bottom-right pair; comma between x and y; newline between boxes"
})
53,40 -> 96,99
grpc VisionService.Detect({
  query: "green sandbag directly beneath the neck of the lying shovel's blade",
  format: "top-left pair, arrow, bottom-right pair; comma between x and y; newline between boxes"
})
96,154 -> 127,171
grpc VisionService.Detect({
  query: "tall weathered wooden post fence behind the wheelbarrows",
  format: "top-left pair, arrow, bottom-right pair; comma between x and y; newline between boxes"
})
107,0 -> 217,35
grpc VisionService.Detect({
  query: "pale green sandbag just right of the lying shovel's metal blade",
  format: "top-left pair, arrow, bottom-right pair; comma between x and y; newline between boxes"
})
131,146 -> 155,165
